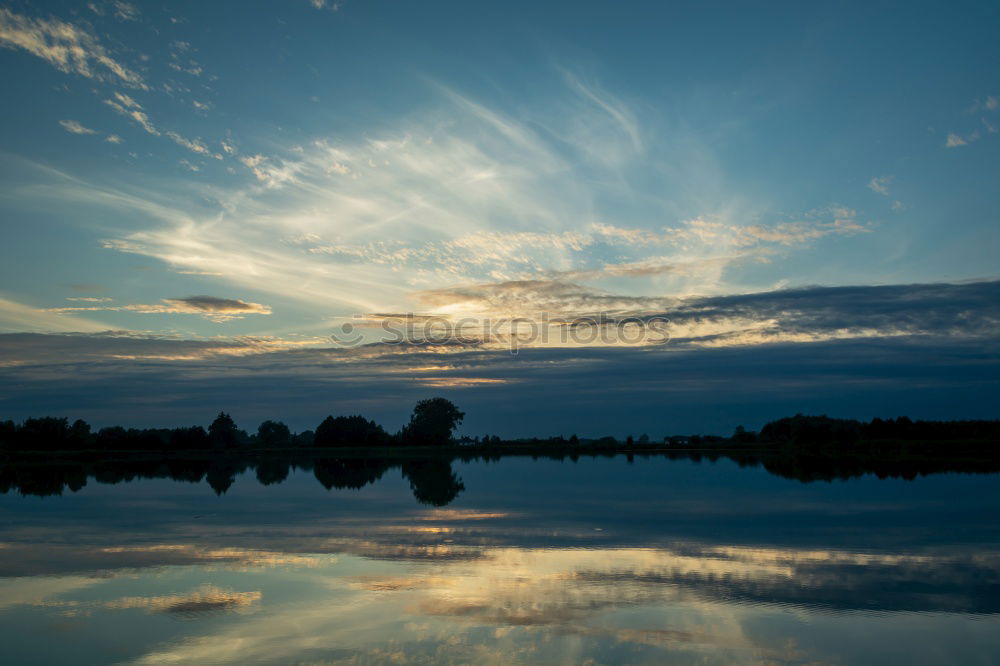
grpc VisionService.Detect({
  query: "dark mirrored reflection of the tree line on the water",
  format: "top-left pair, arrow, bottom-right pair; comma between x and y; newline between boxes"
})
0,449 -> 1000,506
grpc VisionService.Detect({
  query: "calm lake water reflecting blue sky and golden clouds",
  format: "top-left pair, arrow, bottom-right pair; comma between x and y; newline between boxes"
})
0,455 -> 1000,665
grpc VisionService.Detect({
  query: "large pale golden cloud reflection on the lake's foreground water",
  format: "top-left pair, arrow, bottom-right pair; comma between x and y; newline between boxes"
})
117,549 -> 984,663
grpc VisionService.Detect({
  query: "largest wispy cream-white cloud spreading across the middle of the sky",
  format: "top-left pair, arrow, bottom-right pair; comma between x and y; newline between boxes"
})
29,82 -> 870,314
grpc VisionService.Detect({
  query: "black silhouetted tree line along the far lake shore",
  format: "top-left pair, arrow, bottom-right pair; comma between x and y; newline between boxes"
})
0,398 -> 1000,459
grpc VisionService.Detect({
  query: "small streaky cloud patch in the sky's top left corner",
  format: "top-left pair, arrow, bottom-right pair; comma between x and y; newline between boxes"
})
0,8 -> 146,88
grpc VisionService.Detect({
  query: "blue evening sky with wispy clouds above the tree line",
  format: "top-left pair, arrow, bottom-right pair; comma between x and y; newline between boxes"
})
0,0 -> 1000,437
